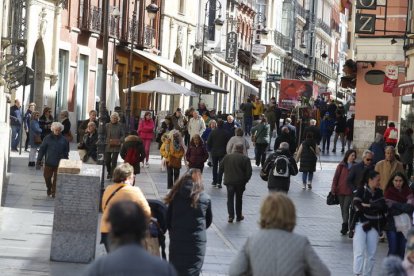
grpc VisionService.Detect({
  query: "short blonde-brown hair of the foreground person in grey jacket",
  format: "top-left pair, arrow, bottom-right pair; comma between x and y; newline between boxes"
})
260,193 -> 296,232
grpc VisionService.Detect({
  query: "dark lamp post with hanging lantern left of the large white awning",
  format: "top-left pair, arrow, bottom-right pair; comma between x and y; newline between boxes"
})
125,0 -> 159,131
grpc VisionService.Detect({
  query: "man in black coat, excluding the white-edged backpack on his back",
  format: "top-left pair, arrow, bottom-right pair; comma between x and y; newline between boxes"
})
261,142 -> 298,193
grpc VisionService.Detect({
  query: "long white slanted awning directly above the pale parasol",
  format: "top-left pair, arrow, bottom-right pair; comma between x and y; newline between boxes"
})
134,50 -> 229,93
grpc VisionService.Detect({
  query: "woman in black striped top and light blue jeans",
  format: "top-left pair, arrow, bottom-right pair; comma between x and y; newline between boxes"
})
353,170 -> 387,276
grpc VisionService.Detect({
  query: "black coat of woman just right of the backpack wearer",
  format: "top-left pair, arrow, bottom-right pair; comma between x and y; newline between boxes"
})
296,139 -> 319,172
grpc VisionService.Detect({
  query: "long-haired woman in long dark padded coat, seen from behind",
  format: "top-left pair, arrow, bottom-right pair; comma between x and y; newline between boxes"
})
165,169 -> 213,276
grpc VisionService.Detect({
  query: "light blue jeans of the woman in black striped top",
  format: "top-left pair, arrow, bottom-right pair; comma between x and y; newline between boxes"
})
353,222 -> 378,276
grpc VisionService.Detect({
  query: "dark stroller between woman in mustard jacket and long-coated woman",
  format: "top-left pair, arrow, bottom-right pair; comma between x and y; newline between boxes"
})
148,199 -> 167,260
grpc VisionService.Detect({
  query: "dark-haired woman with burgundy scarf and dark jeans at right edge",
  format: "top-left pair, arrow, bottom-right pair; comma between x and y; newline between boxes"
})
384,172 -> 414,259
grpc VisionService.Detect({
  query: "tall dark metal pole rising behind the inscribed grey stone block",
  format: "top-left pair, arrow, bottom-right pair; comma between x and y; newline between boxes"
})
96,1 -> 109,207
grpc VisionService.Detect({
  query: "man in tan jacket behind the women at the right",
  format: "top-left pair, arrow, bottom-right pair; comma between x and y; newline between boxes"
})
375,146 -> 405,191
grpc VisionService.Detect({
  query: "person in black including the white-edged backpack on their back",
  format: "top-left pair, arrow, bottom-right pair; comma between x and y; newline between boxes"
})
260,142 -> 298,193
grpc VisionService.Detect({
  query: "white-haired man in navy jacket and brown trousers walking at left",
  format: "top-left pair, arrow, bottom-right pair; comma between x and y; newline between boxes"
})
36,122 -> 69,198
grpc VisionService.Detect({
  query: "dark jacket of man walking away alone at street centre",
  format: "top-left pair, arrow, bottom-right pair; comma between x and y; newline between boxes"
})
219,152 -> 252,187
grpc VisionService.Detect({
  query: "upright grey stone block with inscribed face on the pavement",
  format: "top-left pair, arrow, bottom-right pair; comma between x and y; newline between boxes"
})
50,160 -> 101,263
